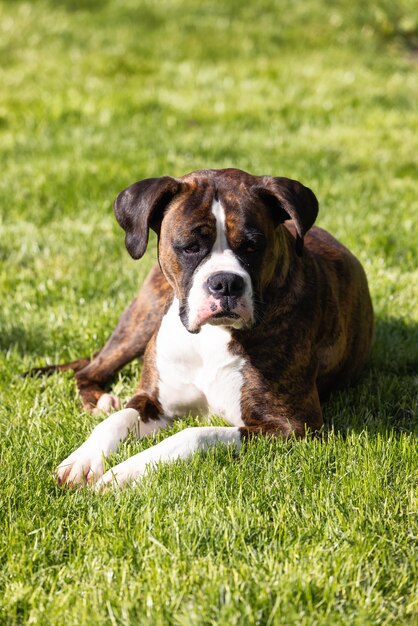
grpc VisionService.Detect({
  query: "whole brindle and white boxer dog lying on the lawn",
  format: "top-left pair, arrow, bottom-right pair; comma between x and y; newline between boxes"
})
30,169 -> 373,490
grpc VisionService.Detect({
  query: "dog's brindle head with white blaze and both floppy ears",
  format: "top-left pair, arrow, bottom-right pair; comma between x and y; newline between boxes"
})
114,169 -> 318,332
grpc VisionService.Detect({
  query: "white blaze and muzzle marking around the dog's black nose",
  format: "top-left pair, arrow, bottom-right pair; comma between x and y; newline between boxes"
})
187,200 -> 254,331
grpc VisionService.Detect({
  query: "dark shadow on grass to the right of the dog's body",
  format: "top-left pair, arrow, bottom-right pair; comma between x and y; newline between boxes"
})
324,318 -> 418,435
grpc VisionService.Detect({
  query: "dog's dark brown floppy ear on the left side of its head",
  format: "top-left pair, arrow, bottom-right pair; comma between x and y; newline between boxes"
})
113,176 -> 182,259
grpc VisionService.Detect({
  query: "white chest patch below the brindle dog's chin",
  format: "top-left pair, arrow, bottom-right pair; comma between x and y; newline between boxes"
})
156,299 -> 244,426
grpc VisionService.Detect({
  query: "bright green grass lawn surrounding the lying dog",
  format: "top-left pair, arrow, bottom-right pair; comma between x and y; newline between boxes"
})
0,0 -> 418,626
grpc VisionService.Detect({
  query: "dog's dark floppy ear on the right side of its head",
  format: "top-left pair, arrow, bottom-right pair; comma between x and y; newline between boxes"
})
257,176 -> 318,256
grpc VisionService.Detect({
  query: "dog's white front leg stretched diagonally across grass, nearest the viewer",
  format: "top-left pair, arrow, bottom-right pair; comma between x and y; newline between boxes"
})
95,426 -> 241,491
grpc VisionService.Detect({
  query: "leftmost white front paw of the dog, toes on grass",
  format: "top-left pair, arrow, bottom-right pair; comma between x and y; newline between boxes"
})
55,442 -> 104,487
